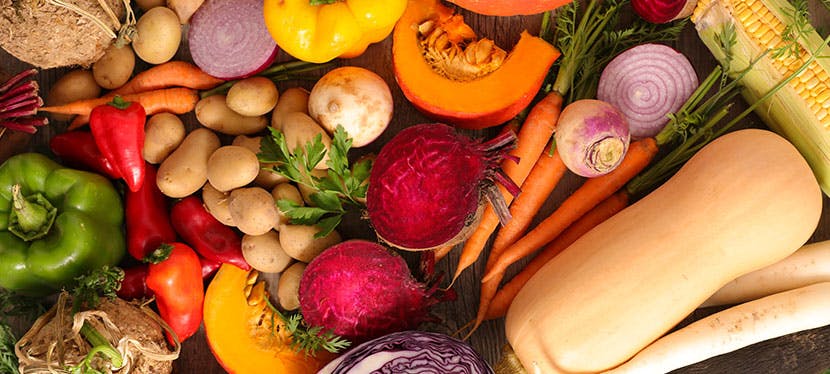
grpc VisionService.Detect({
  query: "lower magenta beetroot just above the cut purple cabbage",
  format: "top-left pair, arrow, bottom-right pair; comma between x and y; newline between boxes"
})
299,240 -> 442,343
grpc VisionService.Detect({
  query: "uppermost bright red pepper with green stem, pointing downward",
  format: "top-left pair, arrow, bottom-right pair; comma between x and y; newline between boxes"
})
89,96 -> 147,191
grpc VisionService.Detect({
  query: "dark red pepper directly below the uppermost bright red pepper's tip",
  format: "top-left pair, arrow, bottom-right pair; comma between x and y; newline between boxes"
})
125,164 -> 176,261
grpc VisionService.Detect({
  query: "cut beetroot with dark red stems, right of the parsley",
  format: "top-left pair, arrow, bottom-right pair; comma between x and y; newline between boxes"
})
366,124 -> 518,250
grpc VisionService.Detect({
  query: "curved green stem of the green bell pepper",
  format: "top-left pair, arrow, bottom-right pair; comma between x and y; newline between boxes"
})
9,184 -> 57,241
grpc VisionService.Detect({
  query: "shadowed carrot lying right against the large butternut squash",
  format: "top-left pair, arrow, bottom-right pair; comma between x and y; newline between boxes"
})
477,190 -> 629,323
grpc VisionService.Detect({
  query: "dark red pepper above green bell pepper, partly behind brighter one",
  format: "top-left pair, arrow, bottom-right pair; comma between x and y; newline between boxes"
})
49,131 -> 121,179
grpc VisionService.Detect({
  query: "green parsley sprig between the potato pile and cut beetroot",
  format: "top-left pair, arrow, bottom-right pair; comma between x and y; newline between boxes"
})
258,126 -> 372,237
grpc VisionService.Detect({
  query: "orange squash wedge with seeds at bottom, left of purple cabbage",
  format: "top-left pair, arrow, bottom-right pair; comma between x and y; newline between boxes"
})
204,264 -> 334,374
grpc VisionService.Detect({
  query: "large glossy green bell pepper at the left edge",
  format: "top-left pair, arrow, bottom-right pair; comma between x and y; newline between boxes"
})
0,153 -> 126,296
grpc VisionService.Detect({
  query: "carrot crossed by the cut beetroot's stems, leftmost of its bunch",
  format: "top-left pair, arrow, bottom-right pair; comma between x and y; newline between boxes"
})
451,92 -> 563,285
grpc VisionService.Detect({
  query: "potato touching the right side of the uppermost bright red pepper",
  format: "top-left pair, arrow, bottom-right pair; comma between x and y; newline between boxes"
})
142,112 -> 187,164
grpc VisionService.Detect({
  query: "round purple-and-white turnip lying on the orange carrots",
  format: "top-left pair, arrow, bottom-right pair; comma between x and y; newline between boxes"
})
554,99 -> 630,178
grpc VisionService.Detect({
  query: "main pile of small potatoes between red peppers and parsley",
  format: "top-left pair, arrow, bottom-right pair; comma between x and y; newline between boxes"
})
144,83 -> 348,310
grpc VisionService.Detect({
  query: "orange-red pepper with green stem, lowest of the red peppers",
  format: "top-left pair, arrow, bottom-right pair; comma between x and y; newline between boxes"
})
147,243 -> 205,344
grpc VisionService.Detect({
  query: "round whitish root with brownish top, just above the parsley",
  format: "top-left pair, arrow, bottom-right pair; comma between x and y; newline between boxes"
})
308,66 -> 393,148
